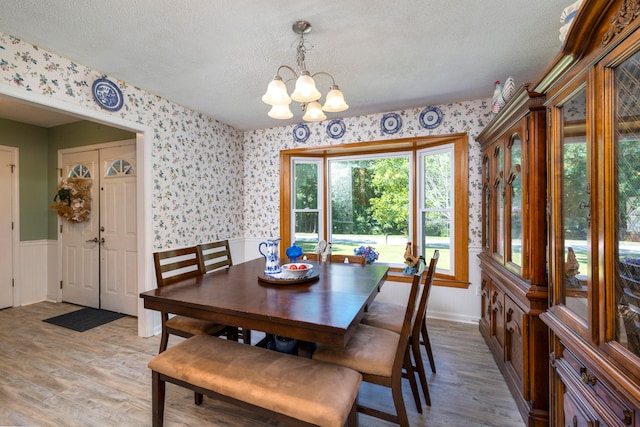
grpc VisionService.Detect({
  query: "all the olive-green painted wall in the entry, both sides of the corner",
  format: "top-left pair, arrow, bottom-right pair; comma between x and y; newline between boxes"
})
0,119 -> 135,241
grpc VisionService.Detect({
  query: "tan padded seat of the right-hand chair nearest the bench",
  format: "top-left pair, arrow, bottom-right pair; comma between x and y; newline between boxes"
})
313,324 -> 400,377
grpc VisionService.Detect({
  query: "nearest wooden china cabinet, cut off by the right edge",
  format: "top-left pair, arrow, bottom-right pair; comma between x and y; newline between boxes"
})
531,0 -> 640,426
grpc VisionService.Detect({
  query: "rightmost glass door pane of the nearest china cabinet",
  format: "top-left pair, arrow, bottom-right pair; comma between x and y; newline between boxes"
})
612,52 -> 640,356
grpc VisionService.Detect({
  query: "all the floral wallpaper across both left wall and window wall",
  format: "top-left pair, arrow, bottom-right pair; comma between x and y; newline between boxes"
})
0,33 -> 493,249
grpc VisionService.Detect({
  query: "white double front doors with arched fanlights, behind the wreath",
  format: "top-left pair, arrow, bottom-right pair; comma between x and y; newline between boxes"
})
62,140 -> 138,316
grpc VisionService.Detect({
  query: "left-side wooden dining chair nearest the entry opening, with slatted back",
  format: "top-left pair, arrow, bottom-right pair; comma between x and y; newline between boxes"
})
153,246 -> 226,353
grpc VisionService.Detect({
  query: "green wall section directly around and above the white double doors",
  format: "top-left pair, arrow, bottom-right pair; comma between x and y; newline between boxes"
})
47,121 -> 136,240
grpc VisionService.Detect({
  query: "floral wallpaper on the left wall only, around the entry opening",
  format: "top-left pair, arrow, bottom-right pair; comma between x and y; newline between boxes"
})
0,33 -> 244,249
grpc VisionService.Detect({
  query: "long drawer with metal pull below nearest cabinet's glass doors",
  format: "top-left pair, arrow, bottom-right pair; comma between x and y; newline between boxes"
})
562,348 -> 634,426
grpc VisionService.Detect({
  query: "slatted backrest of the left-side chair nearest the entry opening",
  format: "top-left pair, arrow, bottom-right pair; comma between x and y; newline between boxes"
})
153,246 -> 203,288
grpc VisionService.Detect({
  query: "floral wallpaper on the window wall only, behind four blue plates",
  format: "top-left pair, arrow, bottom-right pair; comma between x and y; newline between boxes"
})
244,99 -> 494,246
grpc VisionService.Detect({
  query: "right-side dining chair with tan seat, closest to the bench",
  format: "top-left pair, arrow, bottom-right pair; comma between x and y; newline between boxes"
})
313,256 -> 426,427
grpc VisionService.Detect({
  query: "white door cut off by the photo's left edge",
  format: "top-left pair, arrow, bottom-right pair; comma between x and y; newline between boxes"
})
0,147 -> 16,308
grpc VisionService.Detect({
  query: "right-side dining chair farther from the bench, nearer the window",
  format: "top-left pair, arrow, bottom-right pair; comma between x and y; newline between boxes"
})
361,249 -> 440,406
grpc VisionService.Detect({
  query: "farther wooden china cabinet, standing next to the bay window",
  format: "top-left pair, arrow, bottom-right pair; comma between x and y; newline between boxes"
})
477,85 -> 549,426
